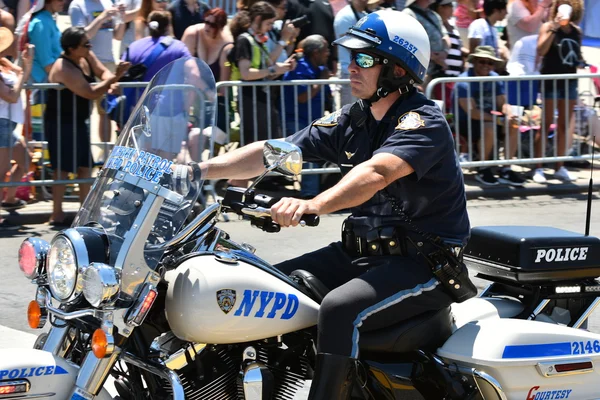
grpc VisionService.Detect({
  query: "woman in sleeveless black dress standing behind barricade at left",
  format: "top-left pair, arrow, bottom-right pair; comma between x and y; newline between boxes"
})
44,26 -> 130,227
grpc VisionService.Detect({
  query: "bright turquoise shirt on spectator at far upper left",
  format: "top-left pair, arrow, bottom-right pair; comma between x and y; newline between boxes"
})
27,10 -> 62,83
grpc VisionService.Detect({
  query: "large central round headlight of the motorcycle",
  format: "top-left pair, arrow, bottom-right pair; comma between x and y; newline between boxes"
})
48,235 -> 77,301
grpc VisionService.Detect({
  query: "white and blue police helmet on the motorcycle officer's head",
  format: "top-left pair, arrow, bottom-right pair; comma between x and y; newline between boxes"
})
333,10 -> 430,101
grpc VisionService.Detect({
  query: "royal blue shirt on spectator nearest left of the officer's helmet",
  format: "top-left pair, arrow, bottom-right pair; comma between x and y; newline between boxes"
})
283,57 -> 331,135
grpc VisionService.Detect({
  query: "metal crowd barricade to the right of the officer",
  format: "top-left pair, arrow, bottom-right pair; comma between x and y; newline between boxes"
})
426,73 -> 600,167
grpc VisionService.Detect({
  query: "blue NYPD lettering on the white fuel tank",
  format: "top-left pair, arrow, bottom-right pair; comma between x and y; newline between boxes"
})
233,290 -> 300,319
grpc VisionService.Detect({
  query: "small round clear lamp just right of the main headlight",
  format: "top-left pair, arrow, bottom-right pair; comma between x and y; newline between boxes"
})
83,263 -> 120,307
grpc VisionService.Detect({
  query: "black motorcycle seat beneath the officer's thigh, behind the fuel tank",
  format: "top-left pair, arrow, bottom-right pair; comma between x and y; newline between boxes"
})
291,269 -> 453,353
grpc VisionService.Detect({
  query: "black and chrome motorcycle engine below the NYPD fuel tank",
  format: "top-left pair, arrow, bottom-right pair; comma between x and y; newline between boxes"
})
155,339 -> 310,400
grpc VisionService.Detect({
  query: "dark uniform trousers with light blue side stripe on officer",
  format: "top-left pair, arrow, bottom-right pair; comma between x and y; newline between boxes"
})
275,242 -> 452,358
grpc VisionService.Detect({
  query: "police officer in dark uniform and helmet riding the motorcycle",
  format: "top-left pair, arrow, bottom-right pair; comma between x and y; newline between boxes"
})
199,10 -> 470,400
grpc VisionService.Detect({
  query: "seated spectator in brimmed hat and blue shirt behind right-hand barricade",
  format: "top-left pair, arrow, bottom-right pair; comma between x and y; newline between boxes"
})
452,46 -> 525,186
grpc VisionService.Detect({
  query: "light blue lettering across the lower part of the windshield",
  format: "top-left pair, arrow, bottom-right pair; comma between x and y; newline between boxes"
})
105,146 -> 173,183
